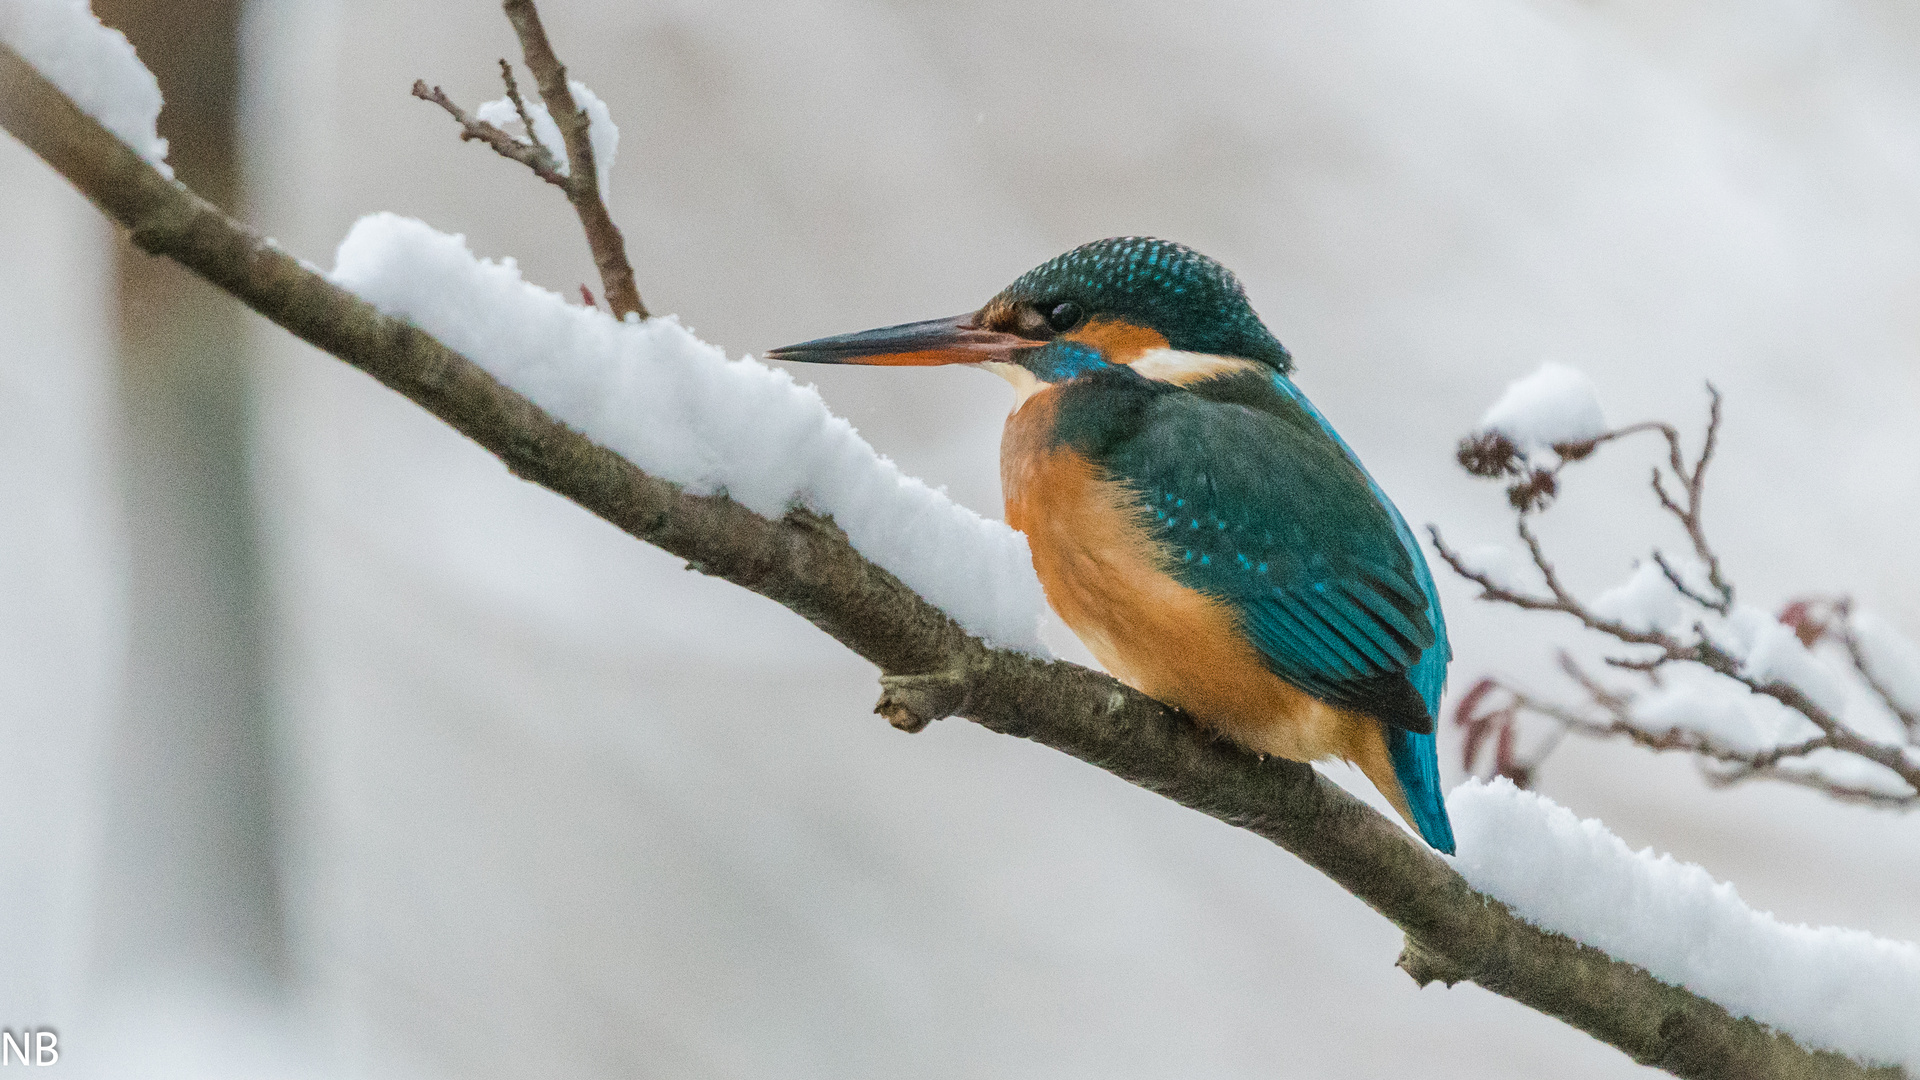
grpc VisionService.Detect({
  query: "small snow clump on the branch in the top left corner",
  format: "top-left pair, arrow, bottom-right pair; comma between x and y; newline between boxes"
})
0,0 -> 173,177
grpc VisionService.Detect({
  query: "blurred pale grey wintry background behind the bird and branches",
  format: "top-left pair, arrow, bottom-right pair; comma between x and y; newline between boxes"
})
0,0 -> 1920,1078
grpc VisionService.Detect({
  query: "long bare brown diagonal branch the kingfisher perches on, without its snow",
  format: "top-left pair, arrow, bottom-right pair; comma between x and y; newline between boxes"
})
0,35 -> 1903,1080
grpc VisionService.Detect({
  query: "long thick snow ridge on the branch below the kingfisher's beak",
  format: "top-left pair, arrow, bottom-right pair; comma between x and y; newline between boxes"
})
330,213 -> 1046,655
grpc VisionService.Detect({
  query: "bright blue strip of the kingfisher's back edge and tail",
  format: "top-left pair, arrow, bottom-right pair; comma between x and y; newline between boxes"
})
1273,375 -> 1453,855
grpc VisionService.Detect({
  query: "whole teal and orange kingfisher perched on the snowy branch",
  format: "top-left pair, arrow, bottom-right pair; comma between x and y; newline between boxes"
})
766,236 -> 1453,853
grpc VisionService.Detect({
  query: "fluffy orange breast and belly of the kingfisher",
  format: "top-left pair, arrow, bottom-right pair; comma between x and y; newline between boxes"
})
1000,392 -> 1409,817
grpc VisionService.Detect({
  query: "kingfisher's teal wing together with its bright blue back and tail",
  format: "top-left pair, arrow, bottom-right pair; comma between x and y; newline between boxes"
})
1060,363 -> 1453,853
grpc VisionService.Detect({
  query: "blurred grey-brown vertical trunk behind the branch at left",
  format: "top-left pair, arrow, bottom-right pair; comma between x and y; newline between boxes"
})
92,0 -> 286,994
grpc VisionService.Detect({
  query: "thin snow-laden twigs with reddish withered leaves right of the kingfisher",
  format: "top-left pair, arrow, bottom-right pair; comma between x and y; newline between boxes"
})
1432,369 -> 1920,807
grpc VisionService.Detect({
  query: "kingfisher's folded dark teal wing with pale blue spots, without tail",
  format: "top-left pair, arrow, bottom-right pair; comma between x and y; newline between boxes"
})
1102,378 -> 1434,732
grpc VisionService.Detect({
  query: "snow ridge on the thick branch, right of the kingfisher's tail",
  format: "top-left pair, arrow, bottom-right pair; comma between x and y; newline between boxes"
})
1448,778 -> 1920,1070
